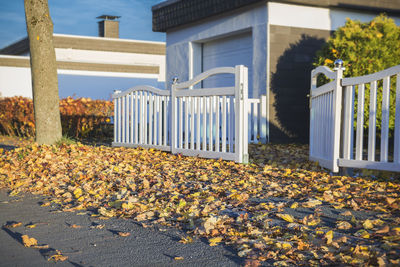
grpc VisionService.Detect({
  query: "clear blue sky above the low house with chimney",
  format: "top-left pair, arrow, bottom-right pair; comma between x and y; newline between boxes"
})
0,0 -> 165,48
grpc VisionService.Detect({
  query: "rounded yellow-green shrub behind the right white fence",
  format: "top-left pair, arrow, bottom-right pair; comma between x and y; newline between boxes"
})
314,15 -> 400,131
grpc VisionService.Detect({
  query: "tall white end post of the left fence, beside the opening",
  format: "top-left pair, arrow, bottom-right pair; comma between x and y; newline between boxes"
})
235,65 -> 248,163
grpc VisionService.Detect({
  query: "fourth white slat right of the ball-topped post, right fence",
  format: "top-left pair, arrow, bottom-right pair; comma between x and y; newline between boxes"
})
381,77 -> 390,162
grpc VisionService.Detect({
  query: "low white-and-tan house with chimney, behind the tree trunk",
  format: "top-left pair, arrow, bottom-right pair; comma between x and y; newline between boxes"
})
0,15 -> 165,99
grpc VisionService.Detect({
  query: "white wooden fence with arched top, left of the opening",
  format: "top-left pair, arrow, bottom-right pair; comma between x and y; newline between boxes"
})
113,66 -> 267,162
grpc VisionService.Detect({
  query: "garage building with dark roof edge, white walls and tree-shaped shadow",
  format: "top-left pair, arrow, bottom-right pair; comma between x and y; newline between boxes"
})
152,0 -> 400,142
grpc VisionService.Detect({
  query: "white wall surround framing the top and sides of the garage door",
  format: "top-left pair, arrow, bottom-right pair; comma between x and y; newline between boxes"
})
166,5 -> 267,96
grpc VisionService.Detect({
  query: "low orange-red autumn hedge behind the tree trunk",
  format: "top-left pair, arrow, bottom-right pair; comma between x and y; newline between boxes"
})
0,97 -> 113,138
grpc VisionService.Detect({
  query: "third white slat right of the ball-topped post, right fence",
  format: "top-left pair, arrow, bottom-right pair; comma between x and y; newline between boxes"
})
368,81 -> 377,161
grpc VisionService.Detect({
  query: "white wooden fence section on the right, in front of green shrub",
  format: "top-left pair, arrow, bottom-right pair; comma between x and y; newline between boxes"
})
310,62 -> 400,172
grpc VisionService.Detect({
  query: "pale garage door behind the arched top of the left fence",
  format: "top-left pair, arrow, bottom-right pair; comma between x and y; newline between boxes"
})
202,32 -> 253,96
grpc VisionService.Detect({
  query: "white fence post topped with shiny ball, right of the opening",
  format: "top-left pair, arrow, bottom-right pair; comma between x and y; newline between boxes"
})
332,59 -> 344,172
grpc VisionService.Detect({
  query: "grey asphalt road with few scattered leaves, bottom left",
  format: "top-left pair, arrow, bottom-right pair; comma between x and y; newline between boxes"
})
0,190 -> 244,266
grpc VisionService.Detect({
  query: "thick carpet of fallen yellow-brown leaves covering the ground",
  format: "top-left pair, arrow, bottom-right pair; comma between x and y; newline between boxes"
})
0,143 -> 400,266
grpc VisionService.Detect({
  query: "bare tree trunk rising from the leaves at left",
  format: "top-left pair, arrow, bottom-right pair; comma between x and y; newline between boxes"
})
24,0 -> 62,144
